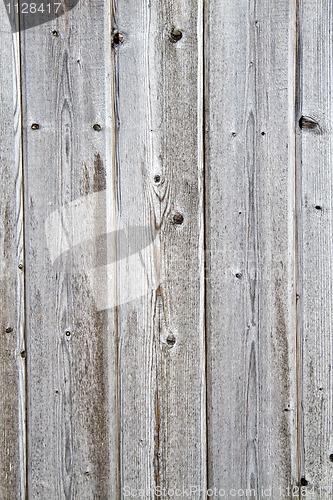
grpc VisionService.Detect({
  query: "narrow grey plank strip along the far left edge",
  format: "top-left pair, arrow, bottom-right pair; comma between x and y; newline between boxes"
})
0,4 -> 26,500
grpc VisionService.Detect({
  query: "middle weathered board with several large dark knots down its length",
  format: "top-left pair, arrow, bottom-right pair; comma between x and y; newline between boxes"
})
115,0 -> 206,499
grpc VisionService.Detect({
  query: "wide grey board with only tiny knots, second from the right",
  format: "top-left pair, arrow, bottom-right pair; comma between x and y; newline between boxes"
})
205,0 -> 296,499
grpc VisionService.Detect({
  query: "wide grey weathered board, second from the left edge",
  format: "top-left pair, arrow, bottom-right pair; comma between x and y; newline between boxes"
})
21,1 -> 118,499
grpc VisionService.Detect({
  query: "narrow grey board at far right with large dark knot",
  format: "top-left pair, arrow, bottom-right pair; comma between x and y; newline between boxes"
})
298,0 -> 333,498
